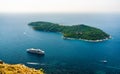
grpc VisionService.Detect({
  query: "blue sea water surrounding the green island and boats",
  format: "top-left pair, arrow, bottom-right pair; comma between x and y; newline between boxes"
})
0,14 -> 120,74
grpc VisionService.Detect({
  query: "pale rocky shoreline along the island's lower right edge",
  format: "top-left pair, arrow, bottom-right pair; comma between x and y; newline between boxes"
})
62,36 -> 112,42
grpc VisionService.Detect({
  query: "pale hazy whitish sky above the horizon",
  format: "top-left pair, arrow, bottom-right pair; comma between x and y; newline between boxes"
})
0,0 -> 120,13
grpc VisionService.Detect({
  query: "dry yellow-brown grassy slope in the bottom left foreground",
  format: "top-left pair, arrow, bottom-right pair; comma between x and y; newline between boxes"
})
0,63 -> 44,74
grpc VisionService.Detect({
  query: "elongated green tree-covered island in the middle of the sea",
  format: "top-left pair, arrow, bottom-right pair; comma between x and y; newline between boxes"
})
28,21 -> 110,42
